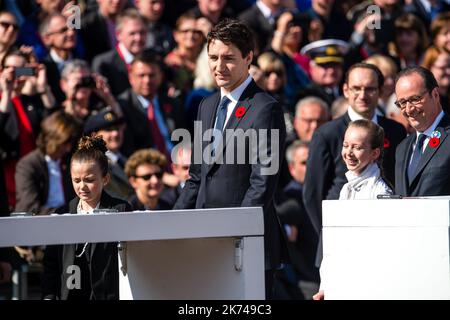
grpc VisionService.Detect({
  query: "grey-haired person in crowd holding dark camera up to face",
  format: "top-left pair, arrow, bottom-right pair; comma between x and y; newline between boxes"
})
60,59 -> 122,121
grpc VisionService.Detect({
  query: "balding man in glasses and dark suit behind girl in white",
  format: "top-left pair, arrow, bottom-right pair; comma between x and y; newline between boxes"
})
303,63 -> 406,241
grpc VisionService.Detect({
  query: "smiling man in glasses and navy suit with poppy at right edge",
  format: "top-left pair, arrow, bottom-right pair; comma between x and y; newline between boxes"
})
395,67 -> 450,197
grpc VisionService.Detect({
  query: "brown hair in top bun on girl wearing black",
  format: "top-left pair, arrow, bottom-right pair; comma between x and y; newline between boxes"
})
70,135 -> 109,177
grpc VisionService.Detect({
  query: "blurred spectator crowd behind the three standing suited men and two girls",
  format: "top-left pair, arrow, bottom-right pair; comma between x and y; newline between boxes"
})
0,0 -> 450,299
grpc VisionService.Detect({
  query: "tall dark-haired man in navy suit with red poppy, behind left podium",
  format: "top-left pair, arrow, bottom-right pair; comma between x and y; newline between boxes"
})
174,19 -> 286,298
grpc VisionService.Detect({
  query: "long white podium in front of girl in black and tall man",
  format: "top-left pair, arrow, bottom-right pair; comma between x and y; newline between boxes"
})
0,208 -> 265,299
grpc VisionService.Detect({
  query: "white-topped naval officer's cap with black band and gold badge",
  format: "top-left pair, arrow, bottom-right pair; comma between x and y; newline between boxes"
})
301,39 -> 348,64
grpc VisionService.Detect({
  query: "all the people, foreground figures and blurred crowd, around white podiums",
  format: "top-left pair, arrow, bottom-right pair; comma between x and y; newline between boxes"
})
0,0 -> 450,299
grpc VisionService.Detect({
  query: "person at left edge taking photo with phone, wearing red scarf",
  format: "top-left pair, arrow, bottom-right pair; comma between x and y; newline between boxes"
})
0,51 -> 53,208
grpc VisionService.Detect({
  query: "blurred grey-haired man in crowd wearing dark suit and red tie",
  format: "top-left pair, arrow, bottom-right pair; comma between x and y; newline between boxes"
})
118,52 -> 184,159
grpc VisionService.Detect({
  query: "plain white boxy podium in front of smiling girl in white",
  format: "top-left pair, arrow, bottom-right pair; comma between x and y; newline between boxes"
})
322,197 -> 450,300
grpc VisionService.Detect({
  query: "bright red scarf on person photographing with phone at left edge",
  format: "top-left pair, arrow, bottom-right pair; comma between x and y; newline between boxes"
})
4,97 -> 36,207
